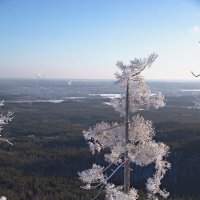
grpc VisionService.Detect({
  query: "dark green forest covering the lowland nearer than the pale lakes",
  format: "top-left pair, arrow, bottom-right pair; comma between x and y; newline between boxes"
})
0,96 -> 200,200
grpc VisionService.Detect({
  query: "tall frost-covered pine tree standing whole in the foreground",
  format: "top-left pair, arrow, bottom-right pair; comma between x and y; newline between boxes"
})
79,53 -> 170,200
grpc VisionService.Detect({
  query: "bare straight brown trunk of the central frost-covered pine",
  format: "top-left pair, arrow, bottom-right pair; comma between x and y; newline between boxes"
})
124,83 -> 130,194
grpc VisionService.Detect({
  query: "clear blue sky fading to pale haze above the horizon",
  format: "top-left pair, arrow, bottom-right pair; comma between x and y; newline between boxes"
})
0,0 -> 200,79
